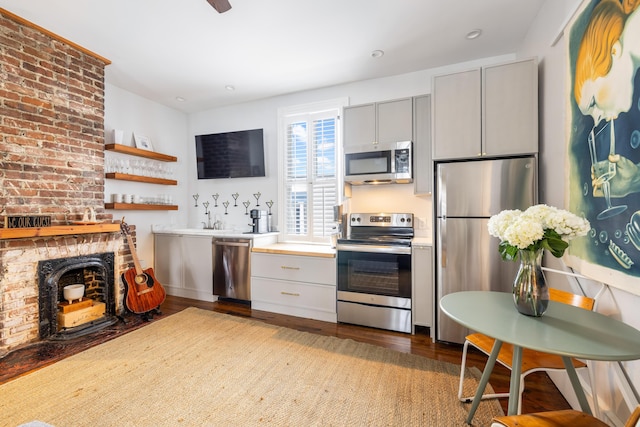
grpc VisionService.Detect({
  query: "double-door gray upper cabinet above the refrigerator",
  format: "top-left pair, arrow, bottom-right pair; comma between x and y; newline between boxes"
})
432,59 -> 538,160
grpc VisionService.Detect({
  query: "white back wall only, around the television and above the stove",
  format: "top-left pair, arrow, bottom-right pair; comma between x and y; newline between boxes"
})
187,55 -> 515,236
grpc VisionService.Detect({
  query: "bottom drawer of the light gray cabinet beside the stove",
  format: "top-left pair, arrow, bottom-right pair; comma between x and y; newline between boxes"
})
251,277 -> 336,315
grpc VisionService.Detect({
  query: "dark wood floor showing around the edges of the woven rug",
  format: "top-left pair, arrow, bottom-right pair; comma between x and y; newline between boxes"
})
0,296 -> 570,413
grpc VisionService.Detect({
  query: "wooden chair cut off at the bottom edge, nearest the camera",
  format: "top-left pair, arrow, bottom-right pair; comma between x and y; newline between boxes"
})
491,406 -> 640,427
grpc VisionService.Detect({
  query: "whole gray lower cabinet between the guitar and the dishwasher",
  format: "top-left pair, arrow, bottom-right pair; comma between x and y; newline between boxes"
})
154,234 -> 214,301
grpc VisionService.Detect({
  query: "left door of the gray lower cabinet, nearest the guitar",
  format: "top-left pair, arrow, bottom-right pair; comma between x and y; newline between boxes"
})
153,234 -> 183,288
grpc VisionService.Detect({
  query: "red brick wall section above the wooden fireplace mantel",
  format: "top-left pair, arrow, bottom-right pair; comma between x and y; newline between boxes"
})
0,10 -> 106,225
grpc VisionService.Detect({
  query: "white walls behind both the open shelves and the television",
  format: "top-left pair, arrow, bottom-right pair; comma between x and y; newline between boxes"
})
105,51 -> 515,247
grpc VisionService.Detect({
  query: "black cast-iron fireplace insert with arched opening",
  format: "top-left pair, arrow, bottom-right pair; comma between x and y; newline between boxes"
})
38,252 -> 118,339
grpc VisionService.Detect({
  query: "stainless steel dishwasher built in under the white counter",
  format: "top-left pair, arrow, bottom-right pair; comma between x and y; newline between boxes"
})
213,237 -> 253,301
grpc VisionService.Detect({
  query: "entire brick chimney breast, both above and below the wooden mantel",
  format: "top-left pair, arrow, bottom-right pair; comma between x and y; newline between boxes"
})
0,9 -> 131,357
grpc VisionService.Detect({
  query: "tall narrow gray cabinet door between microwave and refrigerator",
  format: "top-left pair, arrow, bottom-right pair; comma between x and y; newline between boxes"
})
413,95 -> 433,194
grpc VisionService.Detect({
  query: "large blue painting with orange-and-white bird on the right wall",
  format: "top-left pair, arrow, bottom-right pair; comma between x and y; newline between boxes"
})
565,0 -> 640,295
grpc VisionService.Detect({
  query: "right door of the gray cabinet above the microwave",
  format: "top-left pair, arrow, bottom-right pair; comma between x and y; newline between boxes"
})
376,98 -> 413,143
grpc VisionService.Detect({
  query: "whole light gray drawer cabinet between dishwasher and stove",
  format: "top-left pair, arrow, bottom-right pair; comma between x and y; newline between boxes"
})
251,252 -> 337,323
